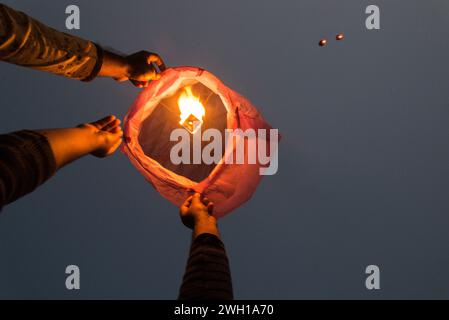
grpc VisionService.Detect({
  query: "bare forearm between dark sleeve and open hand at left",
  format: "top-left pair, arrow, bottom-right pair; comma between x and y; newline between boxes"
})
37,128 -> 98,169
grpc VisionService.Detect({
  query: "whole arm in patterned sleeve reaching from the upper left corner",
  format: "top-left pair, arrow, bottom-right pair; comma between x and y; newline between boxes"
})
0,3 -> 165,87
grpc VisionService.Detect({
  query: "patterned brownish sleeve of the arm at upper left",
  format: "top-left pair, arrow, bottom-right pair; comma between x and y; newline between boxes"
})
0,3 -> 103,81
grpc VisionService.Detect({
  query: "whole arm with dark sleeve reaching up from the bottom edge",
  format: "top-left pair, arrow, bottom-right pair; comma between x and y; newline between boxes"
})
178,193 -> 233,300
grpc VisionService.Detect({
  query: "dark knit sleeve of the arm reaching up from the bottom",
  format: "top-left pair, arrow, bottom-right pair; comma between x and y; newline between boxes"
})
178,233 -> 233,300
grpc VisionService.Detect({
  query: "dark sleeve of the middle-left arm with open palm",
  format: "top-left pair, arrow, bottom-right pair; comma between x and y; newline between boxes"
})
0,131 -> 56,208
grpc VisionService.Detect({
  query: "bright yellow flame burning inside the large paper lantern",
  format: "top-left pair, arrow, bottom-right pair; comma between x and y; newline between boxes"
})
178,87 -> 206,133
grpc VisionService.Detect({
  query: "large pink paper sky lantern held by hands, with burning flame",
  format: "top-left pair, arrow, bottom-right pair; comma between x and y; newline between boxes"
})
122,67 -> 279,218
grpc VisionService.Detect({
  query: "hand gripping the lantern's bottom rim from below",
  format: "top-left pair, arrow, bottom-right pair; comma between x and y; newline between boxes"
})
179,193 -> 217,229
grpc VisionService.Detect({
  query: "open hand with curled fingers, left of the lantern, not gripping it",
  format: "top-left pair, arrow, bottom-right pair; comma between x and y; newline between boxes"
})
78,116 -> 123,158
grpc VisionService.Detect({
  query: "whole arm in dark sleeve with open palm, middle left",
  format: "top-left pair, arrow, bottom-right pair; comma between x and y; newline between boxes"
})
0,117 -> 122,209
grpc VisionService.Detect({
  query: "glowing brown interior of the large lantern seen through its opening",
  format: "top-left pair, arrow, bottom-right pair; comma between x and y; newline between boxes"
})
139,83 -> 227,182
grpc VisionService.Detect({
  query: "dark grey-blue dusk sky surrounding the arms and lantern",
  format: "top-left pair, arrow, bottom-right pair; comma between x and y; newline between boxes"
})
0,0 -> 449,299
